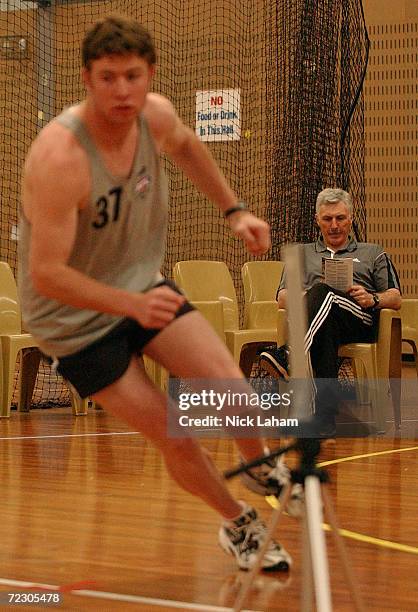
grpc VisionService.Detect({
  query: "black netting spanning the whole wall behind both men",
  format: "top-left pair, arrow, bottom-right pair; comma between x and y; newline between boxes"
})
0,0 -> 367,401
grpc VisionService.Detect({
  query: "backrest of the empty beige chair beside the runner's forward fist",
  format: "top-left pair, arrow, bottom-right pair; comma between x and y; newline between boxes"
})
174,259 -> 239,331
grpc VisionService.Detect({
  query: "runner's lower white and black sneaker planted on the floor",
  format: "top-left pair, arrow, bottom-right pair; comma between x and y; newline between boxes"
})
219,506 -> 292,572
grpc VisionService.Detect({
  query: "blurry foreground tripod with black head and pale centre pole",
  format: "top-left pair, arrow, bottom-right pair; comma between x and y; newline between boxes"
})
224,438 -> 364,612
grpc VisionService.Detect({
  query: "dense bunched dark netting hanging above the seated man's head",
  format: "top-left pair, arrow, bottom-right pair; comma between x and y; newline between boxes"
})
267,0 -> 369,257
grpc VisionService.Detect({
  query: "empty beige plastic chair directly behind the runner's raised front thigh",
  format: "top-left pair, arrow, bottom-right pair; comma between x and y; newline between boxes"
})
173,260 -> 277,376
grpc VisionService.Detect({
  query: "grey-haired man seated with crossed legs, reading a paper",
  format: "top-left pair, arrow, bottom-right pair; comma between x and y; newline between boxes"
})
260,189 -> 401,437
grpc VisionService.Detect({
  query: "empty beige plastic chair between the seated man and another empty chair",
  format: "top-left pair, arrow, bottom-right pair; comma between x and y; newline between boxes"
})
241,261 -> 284,330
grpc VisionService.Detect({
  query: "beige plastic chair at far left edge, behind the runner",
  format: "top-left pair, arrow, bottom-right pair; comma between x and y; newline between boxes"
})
0,261 -> 88,418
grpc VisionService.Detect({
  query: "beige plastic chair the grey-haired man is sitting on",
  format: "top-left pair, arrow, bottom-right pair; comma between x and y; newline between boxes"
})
278,308 -> 402,432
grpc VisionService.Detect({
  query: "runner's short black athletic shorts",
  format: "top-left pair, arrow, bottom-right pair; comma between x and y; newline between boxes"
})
55,280 -> 194,398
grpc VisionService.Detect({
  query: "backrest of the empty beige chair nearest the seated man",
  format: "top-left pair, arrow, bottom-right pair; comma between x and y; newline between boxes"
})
242,261 -> 284,304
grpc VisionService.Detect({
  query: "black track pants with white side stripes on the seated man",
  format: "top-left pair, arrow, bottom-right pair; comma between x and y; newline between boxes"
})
305,283 -> 378,418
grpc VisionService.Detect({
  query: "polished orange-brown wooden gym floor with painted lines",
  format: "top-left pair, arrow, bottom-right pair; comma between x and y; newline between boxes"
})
0,366 -> 418,612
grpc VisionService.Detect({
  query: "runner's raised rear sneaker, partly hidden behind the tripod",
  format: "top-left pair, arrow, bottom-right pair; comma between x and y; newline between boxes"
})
241,459 -> 305,518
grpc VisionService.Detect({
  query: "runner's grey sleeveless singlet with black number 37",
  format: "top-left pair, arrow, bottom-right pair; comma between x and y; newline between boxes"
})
18,109 -> 168,357
